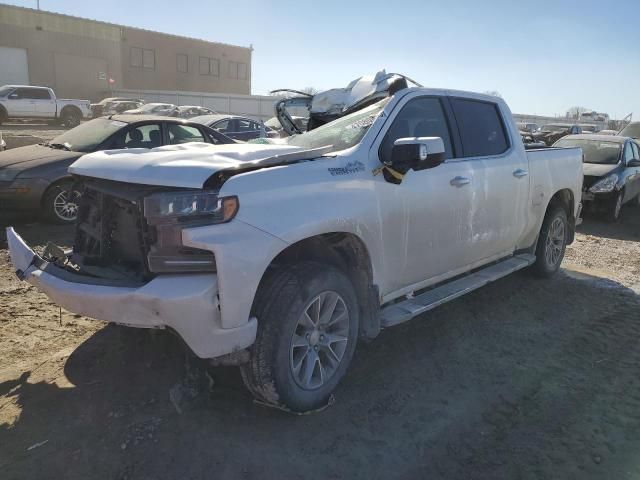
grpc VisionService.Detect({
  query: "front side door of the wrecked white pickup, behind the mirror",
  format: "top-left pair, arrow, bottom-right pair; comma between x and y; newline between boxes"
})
370,96 -> 475,296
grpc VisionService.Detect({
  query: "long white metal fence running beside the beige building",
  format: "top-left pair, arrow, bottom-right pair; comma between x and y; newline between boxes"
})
110,89 -> 277,120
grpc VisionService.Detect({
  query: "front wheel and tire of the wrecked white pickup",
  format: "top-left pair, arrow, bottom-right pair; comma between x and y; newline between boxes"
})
240,262 -> 359,412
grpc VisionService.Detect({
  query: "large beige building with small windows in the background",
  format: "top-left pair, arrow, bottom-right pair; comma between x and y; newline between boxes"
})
0,5 -> 252,101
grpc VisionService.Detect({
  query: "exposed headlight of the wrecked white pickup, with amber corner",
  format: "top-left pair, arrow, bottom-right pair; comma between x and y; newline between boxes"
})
144,192 -> 239,223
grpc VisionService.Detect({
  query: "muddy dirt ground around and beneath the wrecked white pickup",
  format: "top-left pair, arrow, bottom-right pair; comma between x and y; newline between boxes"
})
0,208 -> 640,480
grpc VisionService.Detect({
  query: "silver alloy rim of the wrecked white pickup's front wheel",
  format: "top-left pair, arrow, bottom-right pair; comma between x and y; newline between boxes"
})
289,291 -> 350,390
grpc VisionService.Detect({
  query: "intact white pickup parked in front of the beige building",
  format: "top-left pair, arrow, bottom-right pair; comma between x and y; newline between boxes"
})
0,85 -> 91,128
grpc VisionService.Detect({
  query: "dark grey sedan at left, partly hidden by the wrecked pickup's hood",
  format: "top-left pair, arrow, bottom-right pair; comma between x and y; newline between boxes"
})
0,115 -> 236,223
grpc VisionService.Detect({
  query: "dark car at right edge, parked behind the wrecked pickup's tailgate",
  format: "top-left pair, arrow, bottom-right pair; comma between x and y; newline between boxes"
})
554,135 -> 640,221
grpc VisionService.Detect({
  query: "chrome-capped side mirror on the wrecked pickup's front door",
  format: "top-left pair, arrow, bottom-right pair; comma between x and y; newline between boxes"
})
391,137 -> 445,174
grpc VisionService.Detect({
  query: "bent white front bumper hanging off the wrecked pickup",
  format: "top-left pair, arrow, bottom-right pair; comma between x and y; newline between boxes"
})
7,228 -> 257,358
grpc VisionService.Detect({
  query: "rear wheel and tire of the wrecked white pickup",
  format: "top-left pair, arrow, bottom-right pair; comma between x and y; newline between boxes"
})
532,207 -> 569,278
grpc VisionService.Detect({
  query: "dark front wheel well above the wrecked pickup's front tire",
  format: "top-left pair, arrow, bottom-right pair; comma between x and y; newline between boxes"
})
258,232 -> 380,338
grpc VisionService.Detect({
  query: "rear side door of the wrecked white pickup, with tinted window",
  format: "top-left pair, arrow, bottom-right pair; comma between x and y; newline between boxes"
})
449,97 -> 530,263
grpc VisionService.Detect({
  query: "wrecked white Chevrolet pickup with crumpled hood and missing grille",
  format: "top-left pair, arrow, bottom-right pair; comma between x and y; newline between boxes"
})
7,78 -> 582,411
